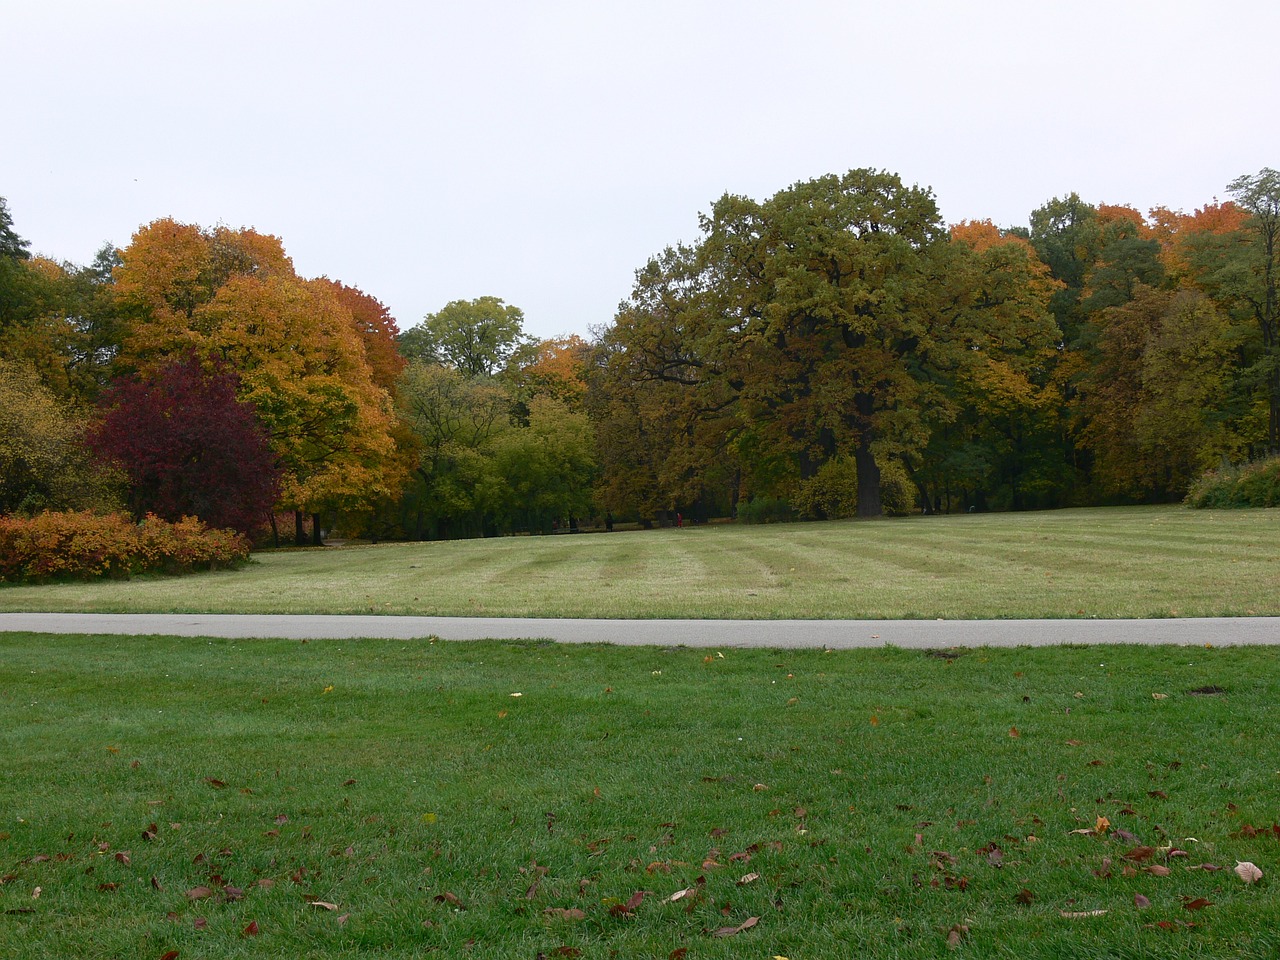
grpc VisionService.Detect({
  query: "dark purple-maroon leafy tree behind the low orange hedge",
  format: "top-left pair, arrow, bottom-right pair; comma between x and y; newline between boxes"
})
88,355 -> 280,534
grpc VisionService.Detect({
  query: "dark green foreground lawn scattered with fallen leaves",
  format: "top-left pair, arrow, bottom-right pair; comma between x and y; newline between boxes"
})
0,634 -> 1280,960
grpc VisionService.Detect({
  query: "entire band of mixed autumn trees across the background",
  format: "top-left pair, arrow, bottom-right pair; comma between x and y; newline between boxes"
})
0,169 -> 1280,541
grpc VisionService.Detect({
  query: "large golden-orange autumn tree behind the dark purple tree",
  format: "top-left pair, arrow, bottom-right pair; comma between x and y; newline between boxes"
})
115,220 -> 399,539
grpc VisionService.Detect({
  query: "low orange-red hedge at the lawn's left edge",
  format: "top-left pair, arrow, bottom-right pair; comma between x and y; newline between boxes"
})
0,511 -> 248,584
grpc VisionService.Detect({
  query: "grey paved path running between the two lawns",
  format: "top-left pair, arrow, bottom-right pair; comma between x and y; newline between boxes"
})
0,613 -> 1280,650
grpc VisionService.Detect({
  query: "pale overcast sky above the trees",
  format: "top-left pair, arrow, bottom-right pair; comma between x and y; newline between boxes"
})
0,0 -> 1280,338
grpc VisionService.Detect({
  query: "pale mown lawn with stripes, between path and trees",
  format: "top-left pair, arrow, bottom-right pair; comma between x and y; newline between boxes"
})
0,507 -> 1280,618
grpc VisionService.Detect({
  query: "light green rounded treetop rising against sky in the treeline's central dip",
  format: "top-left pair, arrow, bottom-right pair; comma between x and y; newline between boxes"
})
399,297 -> 529,378
